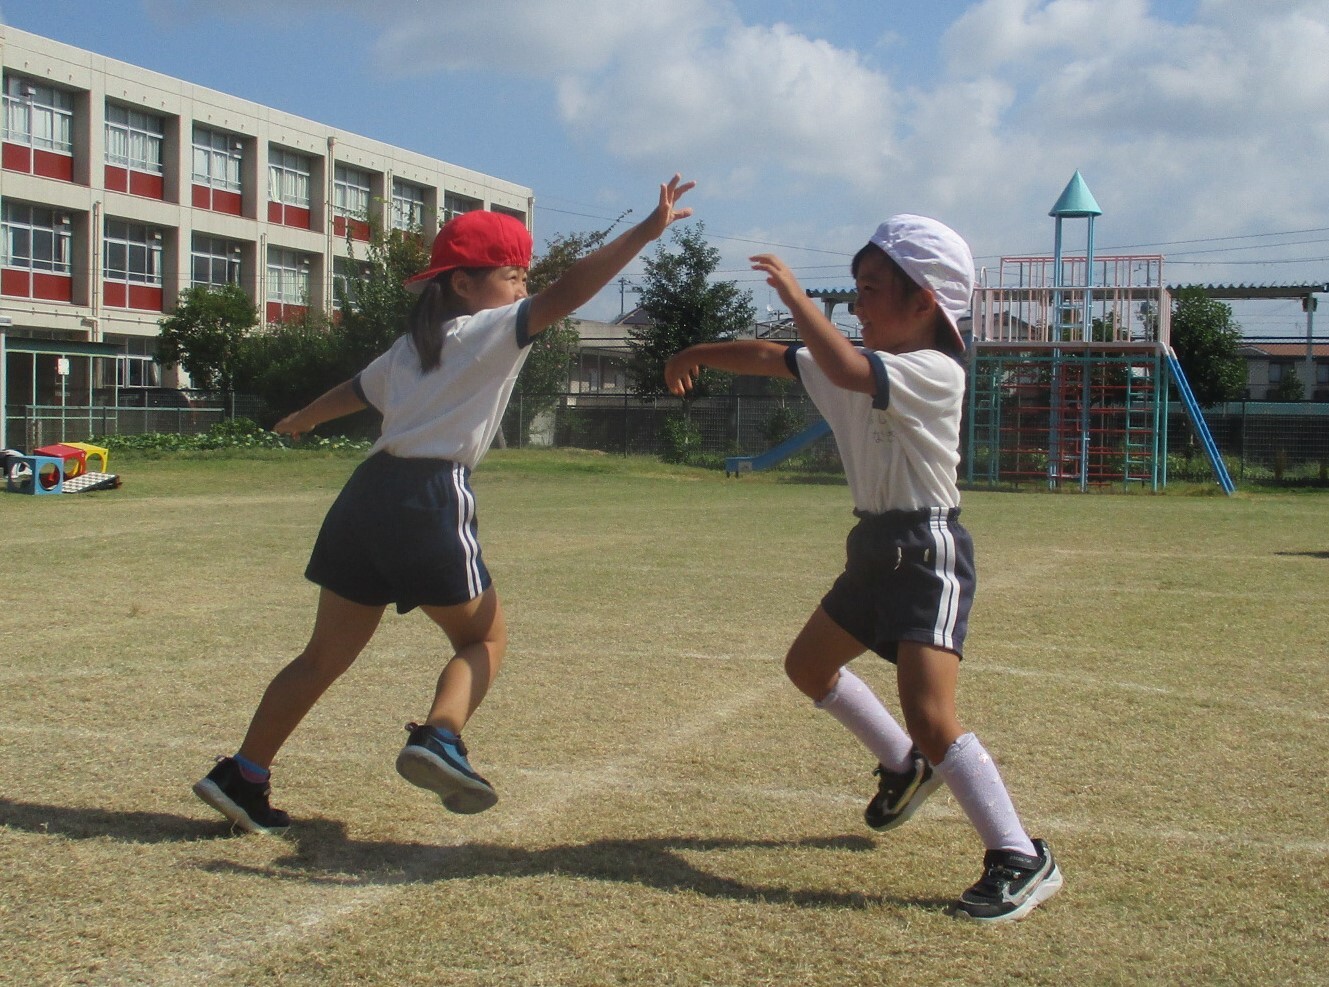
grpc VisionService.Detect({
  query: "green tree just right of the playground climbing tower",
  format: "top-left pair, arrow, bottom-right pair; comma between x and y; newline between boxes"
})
1172,287 -> 1247,405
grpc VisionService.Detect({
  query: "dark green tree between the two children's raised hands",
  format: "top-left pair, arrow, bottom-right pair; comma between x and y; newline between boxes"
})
627,223 -> 756,397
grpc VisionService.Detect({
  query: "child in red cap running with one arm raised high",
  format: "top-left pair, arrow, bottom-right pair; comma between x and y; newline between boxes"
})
194,175 -> 694,833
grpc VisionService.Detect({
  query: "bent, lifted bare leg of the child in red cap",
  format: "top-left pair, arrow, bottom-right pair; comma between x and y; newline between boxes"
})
420,586 -> 508,733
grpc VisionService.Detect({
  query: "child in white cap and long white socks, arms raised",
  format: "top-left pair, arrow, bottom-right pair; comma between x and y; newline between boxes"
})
665,215 -> 1062,922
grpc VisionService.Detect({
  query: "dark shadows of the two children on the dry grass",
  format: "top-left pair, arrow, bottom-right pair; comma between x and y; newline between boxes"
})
0,797 -> 950,909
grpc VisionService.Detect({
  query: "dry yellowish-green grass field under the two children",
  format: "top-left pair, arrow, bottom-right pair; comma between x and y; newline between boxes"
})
0,452 -> 1329,987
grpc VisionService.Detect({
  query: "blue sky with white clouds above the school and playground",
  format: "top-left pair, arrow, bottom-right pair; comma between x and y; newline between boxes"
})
0,0 -> 1329,337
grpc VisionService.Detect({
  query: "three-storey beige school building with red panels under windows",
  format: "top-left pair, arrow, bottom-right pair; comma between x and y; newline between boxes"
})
0,24 -> 534,445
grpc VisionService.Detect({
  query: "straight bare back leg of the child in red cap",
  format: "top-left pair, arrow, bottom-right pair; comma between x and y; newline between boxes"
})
239,590 -> 384,768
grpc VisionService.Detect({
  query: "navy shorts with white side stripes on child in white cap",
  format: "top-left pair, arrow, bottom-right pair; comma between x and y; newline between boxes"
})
821,507 -> 975,662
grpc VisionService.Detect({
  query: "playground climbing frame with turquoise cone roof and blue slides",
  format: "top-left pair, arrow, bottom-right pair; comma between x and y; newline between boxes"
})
724,171 -> 1235,494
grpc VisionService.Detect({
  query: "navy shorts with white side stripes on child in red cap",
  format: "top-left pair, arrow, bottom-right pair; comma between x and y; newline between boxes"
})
304,452 -> 490,614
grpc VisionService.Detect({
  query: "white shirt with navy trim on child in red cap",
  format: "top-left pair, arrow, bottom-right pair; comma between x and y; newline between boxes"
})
355,299 -> 530,466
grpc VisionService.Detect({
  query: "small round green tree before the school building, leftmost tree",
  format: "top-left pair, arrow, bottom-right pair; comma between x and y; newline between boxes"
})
157,284 -> 258,393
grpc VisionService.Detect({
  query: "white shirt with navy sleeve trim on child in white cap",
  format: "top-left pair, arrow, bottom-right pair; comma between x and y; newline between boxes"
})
785,345 -> 965,514
